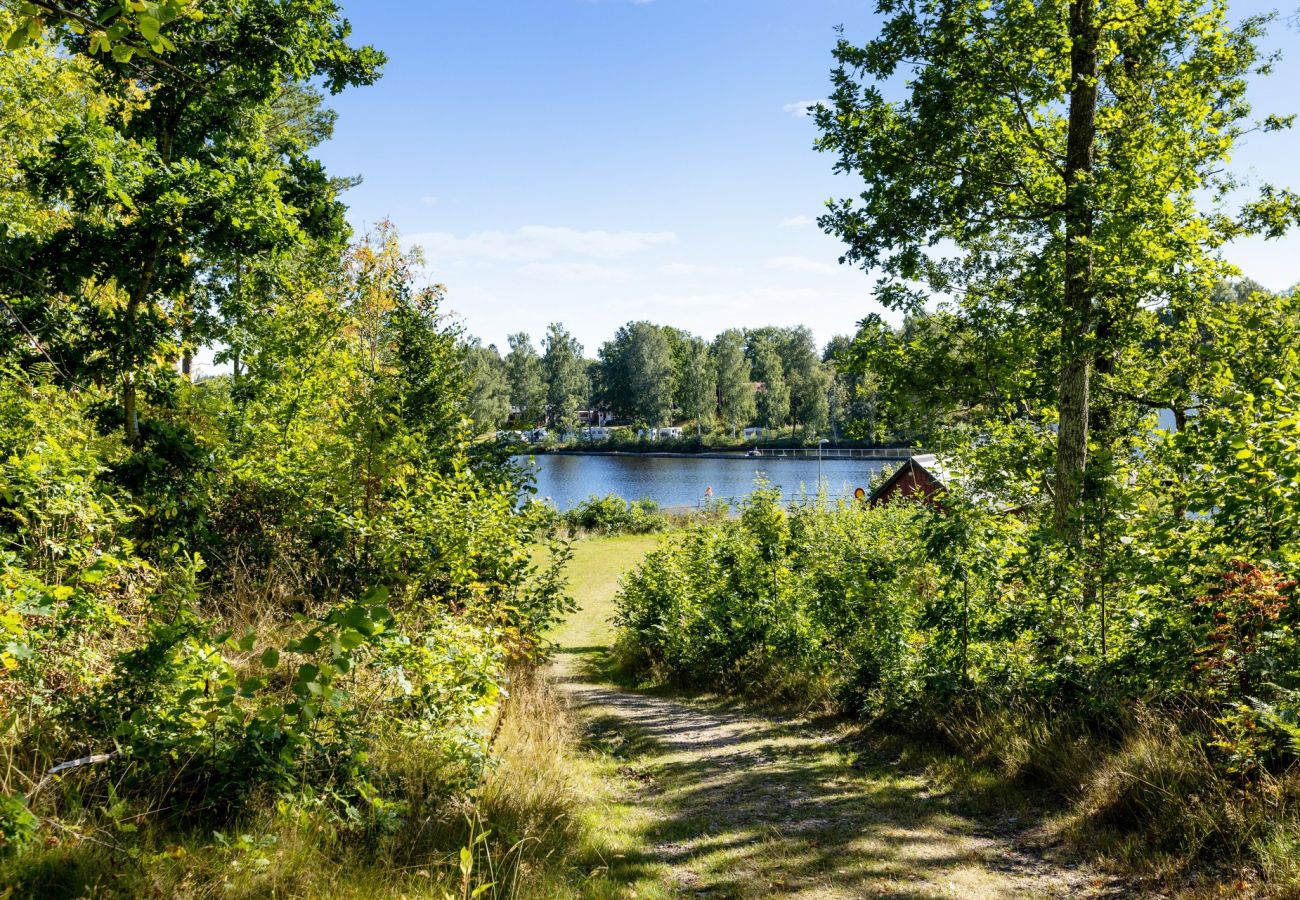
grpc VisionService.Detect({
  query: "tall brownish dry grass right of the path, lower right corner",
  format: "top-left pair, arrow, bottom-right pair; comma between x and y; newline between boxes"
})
914,708 -> 1300,897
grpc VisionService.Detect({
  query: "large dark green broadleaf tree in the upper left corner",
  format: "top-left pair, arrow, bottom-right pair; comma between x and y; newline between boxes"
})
0,0 -> 384,445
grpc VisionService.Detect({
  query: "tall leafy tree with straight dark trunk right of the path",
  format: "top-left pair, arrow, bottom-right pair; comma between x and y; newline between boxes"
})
815,0 -> 1300,540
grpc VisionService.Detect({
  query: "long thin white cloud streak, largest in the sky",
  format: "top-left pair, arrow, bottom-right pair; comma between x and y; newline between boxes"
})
406,225 -> 677,265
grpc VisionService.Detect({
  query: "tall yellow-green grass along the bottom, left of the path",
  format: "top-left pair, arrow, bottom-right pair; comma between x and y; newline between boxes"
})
0,652 -> 611,900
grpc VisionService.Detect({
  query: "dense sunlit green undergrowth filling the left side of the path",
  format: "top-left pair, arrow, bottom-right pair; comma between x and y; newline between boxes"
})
0,223 -> 598,896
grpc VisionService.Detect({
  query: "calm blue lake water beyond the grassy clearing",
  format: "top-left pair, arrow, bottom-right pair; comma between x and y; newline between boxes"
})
517,454 -> 894,510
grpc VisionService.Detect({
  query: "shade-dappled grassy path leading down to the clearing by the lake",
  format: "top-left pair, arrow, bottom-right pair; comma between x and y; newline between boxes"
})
554,537 -> 1110,899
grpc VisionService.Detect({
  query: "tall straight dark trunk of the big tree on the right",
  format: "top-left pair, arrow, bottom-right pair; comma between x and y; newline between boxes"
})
1054,0 -> 1097,540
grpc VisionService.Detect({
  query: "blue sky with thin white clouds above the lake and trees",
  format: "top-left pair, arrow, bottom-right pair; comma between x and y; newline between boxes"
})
321,0 -> 1300,355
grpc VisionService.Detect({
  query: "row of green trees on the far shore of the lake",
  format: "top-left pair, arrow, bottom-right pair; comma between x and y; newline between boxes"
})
464,321 -> 874,440
